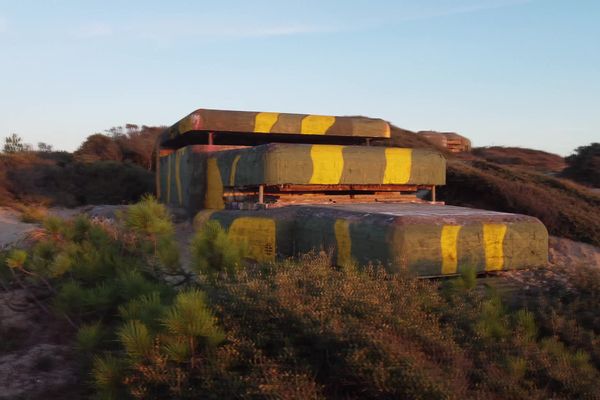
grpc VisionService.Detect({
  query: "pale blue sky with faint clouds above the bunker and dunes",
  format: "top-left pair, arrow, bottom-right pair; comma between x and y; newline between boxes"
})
0,0 -> 600,155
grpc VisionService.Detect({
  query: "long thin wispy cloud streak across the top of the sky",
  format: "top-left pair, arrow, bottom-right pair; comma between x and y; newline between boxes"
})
68,0 -> 535,45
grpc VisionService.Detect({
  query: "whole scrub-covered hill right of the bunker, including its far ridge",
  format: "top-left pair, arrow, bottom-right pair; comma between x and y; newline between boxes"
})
384,127 -> 600,246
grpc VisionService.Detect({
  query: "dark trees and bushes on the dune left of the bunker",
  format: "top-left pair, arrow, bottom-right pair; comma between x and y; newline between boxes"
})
0,124 -> 162,207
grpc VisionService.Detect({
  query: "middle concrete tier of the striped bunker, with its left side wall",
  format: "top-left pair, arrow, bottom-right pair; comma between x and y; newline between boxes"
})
157,143 -> 446,214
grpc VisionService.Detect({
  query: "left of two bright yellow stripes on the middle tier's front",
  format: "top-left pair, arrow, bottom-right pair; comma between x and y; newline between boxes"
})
309,144 -> 344,185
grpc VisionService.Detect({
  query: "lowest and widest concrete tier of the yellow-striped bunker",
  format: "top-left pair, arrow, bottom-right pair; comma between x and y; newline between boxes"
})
196,204 -> 548,276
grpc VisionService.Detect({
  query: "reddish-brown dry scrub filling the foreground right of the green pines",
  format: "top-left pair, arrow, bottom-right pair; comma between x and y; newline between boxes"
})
200,255 -> 600,399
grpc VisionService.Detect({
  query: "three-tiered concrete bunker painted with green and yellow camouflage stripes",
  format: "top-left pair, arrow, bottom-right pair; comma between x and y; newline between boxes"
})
156,109 -> 548,276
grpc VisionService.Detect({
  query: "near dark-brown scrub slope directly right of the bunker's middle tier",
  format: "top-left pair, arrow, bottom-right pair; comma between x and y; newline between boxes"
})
439,160 -> 600,246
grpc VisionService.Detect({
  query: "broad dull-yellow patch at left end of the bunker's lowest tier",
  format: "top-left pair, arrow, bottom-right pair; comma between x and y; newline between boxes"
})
228,217 -> 276,262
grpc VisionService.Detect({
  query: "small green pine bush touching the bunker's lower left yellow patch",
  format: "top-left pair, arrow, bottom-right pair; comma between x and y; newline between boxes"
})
191,220 -> 245,278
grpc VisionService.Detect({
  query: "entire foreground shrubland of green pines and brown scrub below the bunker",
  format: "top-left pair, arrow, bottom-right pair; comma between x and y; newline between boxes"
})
0,198 -> 600,399
